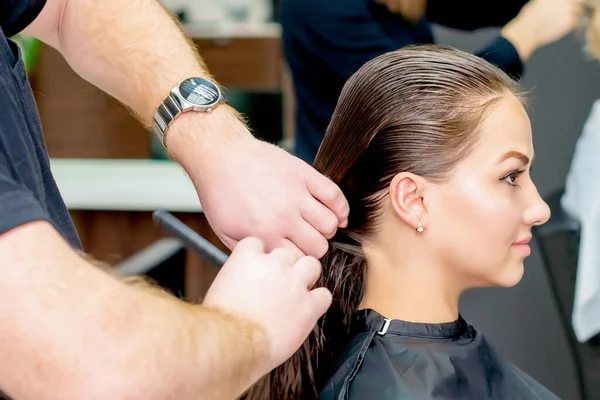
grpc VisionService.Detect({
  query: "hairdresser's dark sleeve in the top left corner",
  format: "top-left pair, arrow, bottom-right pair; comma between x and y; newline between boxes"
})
0,0 -> 46,37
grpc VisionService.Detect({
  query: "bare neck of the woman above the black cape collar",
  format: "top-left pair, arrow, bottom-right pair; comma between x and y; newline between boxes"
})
360,242 -> 463,323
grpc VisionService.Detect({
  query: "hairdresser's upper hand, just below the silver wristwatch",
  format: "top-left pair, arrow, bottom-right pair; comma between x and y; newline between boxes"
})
167,107 -> 348,257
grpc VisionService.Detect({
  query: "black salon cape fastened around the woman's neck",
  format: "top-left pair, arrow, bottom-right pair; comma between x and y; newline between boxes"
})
319,310 -> 558,400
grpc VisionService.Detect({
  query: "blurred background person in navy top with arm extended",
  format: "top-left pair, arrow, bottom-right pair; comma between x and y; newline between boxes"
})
280,0 -> 580,163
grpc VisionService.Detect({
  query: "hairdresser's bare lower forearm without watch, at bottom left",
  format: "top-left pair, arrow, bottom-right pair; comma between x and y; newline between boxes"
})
0,223 -> 264,400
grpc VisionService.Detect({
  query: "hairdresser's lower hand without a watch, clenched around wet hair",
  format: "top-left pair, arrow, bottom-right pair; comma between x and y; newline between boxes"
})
204,238 -> 331,379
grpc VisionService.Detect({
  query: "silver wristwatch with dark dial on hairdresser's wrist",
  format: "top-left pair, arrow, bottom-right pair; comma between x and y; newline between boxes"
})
152,78 -> 225,145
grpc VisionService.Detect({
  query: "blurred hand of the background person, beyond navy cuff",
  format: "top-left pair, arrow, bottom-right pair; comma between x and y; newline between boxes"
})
502,0 -> 583,61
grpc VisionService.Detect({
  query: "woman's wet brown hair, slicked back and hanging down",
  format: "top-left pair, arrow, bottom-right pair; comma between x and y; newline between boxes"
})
245,45 -> 523,400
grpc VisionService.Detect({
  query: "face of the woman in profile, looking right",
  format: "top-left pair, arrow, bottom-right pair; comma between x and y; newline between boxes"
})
426,95 -> 550,287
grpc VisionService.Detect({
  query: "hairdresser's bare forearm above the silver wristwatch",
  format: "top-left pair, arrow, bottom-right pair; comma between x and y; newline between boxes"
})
29,0 -> 245,133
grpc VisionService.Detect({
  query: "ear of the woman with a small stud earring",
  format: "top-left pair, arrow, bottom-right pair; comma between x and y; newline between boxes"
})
390,172 -> 427,230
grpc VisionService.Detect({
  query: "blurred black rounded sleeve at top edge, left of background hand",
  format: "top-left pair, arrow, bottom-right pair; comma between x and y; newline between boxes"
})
426,0 -> 528,30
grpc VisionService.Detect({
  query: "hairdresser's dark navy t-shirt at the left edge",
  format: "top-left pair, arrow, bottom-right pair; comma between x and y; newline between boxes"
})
0,0 -> 81,248
